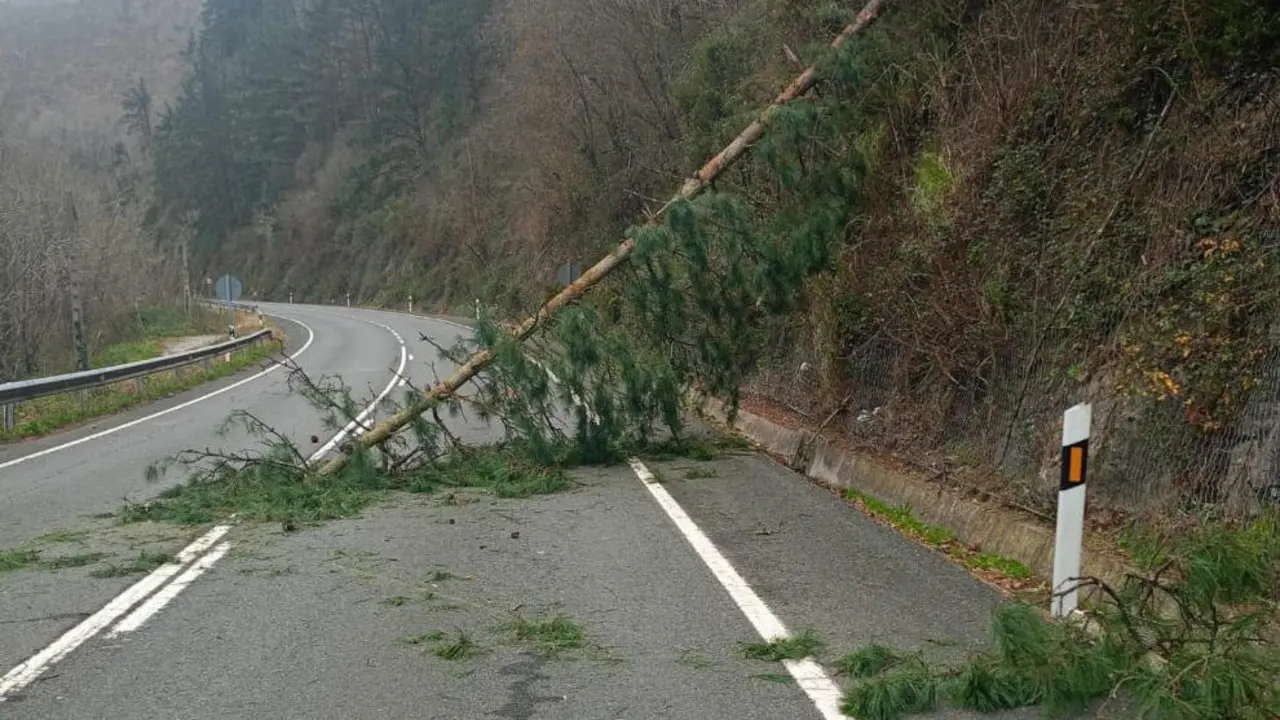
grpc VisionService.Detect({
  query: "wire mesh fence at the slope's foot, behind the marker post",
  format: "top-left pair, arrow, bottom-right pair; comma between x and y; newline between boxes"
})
745,308 -> 1280,523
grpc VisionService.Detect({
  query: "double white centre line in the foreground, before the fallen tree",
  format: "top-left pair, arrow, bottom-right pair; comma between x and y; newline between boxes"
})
0,525 -> 232,702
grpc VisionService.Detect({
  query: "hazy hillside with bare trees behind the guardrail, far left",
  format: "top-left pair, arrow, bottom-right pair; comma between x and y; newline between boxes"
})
0,0 -> 198,382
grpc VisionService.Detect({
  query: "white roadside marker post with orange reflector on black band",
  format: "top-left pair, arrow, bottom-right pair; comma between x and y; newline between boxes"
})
1052,404 -> 1093,618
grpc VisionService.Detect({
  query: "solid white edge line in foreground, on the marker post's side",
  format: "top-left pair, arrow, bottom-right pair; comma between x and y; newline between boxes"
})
630,457 -> 847,720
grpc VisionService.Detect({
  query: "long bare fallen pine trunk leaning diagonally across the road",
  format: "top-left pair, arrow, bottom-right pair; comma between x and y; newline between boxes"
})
320,0 -> 888,475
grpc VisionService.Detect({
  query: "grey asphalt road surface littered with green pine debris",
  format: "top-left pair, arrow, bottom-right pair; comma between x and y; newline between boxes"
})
0,305 -> 1036,720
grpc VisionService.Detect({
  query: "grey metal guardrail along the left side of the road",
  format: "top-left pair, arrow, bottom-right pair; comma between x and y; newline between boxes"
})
0,328 -> 271,432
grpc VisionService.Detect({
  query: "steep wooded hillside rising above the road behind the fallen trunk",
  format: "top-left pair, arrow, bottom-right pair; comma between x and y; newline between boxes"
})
152,0 -> 1280,510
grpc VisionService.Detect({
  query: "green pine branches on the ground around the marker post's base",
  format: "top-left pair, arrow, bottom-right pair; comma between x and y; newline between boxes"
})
841,516 -> 1280,720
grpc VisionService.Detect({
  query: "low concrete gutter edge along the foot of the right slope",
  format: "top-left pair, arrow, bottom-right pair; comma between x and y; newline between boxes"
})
696,397 -> 1129,587
